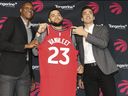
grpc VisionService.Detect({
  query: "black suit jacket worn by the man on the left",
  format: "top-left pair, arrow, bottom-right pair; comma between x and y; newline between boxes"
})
0,17 -> 34,76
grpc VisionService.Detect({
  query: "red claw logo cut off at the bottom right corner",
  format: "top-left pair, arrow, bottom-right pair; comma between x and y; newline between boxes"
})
118,80 -> 128,96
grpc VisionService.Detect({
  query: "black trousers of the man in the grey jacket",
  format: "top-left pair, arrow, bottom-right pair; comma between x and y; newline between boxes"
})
83,65 -> 116,96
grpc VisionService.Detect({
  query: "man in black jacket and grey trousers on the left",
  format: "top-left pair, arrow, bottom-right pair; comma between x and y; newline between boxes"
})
0,2 -> 36,96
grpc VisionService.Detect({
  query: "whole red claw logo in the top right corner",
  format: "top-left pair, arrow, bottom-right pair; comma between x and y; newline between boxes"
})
109,2 -> 122,15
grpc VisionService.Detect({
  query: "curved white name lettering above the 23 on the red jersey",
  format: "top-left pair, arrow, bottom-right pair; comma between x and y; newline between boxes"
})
48,37 -> 71,46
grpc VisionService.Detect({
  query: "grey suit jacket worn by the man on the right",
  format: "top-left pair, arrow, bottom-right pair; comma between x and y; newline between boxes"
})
76,26 -> 118,74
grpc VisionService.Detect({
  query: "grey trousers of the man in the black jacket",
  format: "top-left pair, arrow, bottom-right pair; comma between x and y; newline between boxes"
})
0,66 -> 31,96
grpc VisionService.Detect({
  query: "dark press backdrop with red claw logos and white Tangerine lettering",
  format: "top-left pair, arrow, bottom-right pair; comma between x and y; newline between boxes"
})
0,0 -> 128,96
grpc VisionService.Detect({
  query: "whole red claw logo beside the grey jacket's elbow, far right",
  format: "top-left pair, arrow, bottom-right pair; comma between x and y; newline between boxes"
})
114,39 -> 128,53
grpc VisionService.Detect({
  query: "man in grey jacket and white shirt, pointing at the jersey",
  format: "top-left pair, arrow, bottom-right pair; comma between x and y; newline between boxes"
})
74,6 -> 118,96
